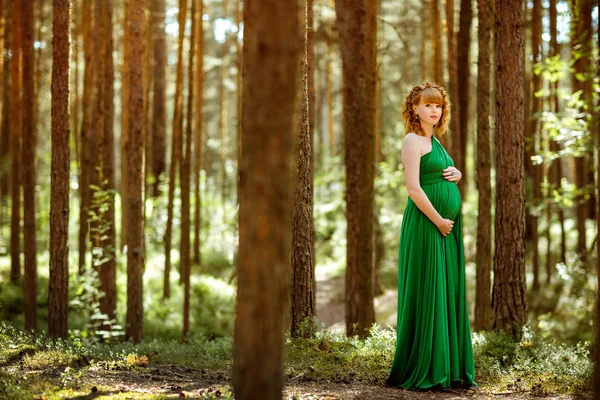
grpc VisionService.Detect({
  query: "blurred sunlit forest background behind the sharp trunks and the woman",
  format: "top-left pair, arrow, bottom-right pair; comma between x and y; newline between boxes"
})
0,0 -> 600,360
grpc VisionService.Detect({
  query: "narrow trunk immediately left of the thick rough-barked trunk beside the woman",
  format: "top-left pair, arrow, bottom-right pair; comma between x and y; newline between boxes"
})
475,0 -> 494,331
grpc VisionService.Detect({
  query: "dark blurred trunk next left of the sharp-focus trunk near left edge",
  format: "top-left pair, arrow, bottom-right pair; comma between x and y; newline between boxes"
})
21,1 -> 37,332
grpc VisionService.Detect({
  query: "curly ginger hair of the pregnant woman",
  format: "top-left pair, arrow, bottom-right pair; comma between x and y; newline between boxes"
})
402,82 -> 451,136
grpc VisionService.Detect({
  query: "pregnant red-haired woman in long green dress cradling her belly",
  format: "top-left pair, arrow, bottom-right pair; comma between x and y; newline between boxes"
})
387,83 -> 477,389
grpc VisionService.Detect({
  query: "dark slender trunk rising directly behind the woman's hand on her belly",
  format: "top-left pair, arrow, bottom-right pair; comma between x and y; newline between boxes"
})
458,0 -> 473,197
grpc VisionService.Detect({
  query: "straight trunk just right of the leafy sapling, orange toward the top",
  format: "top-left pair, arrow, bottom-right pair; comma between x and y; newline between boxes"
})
125,0 -> 147,343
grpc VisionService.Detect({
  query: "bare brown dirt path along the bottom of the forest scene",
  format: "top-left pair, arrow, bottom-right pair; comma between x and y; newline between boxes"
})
54,365 -> 593,400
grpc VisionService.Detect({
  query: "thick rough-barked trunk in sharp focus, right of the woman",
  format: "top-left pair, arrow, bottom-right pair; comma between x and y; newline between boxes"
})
492,0 -> 527,336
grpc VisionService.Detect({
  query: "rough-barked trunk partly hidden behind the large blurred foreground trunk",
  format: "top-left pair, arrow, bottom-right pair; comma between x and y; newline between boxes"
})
290,0 -> 315,337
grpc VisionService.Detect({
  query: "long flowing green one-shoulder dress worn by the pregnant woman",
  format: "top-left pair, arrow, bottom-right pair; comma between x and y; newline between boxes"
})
387,138 -> 477,389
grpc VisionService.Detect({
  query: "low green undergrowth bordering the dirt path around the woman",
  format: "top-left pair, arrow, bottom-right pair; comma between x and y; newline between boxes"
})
0,324 -> 593,399
